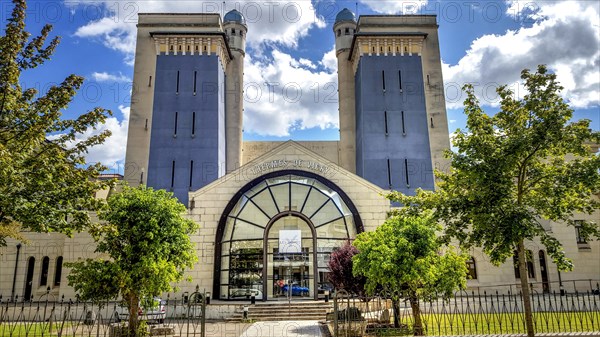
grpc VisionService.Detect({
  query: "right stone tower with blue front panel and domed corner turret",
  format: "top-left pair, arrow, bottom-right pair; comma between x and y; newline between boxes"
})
333,8 -> 450,194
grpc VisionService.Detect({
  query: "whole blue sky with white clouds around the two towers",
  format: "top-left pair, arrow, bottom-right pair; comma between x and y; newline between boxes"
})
0,0 -> 600,173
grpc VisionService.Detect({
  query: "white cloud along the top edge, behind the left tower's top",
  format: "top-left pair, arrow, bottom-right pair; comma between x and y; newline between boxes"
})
66,0 -> 325,60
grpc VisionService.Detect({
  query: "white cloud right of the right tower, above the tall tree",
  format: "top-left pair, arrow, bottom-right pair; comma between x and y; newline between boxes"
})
442,1 -> 600,108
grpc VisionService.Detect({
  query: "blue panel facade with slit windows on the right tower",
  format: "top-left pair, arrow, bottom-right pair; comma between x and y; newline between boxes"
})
355,55 -> 434,194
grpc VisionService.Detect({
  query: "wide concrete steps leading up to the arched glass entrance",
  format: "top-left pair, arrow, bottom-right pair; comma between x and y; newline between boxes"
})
229,300 -> 333,321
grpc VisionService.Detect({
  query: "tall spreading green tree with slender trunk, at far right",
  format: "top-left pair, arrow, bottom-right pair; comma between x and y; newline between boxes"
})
389,65 -> 600,336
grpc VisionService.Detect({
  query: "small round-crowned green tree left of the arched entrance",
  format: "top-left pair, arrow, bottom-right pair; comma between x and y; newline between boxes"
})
67,186 -> 198,336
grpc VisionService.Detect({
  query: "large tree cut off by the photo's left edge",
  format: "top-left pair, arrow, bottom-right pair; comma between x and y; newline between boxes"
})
0,0 -> 111,246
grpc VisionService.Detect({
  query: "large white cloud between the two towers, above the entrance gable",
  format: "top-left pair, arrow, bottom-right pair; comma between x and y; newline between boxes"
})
244,50 -> 338,137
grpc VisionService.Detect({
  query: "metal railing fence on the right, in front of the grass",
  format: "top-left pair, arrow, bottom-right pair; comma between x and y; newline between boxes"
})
327,283 -> 600,337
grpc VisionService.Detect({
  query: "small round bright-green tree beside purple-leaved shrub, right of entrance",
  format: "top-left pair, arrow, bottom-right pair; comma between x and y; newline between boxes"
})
353,215 -> 467,336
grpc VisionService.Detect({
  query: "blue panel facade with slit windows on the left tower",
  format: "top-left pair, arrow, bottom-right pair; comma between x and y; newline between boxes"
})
147,55 -> 225,205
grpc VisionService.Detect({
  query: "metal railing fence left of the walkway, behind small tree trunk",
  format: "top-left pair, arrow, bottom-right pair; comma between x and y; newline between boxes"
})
0,289 -> 206,337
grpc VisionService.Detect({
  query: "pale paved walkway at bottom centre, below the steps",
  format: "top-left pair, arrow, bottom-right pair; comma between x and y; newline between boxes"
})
206,321 -> 323,337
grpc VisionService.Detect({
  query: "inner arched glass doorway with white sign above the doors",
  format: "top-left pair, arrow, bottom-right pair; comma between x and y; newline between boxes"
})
266,214 -> 315,299
